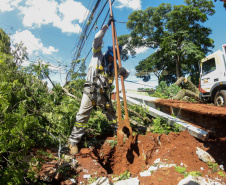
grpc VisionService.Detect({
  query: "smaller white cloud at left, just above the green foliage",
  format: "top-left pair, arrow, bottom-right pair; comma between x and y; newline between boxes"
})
11,30 -> 58,55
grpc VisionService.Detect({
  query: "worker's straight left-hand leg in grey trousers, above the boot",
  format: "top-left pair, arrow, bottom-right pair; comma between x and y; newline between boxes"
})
69,88 -> 93,145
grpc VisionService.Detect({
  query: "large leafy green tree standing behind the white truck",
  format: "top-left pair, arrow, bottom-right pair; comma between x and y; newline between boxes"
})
119,0 -> 215,84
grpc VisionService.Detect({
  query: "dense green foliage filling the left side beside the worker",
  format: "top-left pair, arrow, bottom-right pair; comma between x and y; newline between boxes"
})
0,30 -> 84,184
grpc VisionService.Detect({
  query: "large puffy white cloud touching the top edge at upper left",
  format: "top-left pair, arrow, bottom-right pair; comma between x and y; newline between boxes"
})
19,0 -> 89,33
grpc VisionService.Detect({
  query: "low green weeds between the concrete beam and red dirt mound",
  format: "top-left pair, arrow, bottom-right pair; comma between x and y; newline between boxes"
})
150,117 -> 180,134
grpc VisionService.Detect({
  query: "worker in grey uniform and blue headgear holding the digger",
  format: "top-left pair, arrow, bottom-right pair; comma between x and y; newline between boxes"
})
69,17 -> 129,155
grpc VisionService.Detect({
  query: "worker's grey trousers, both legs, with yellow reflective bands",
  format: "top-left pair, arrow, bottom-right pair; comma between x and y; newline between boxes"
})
69,87 -> 117,144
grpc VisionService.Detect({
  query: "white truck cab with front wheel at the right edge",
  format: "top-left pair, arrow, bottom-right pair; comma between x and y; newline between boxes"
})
199,44 -> 226,107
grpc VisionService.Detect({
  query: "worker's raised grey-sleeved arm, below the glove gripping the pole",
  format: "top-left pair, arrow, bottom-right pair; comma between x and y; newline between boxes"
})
92,25 -> 108,55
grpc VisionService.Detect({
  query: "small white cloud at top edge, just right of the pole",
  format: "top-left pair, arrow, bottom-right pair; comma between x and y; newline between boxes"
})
116,0 -> 141,10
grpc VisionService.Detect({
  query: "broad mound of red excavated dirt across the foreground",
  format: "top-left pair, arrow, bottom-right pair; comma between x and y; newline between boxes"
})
76,131 -> 226,184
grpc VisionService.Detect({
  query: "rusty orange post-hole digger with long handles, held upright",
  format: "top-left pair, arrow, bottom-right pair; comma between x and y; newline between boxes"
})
109,0 -> 133,146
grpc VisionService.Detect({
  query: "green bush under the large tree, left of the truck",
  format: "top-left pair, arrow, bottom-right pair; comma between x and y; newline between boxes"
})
151,81 -> 181,99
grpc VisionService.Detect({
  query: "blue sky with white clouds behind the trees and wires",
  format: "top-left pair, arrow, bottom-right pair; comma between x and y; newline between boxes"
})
0,0 -> 226,89
